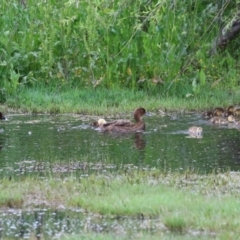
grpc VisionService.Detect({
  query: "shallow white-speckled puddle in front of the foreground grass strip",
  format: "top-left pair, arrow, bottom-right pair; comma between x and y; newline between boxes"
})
0,209 -> 166,239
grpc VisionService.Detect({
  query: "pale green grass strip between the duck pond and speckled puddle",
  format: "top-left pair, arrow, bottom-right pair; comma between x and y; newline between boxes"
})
0,171 -> 240,239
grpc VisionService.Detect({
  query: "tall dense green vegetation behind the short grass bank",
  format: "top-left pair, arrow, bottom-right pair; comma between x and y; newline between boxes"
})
0,0 -> 240,107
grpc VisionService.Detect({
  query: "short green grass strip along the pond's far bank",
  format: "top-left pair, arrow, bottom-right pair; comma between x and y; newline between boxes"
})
2,87 -> 240,115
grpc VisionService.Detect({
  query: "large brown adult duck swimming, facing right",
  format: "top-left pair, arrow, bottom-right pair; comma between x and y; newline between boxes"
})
99,107 -> 147,132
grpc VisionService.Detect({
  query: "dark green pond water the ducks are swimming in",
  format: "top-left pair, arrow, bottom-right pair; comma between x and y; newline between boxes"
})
0,114 -> 240,175
